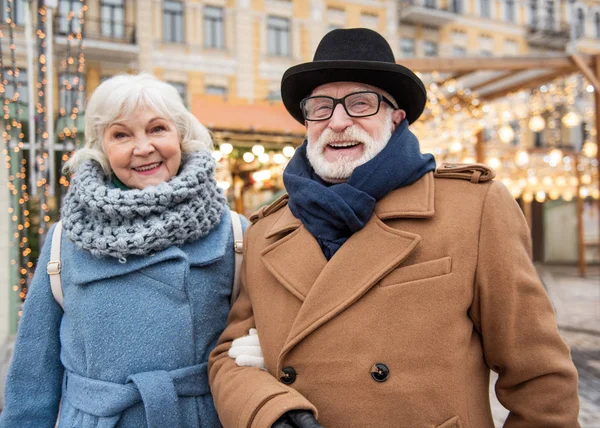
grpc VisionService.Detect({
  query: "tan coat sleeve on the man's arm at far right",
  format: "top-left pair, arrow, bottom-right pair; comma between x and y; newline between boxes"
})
471,182 -> 579,428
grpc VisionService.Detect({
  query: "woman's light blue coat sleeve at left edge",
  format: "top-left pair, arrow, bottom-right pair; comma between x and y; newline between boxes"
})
0,227 -> 64,428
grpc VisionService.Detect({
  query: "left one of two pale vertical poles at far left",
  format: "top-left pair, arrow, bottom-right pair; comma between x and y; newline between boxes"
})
25,0 -> 37,196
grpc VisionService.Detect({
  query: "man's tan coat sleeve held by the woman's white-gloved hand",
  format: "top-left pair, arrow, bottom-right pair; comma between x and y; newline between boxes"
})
208,222 -> 317,428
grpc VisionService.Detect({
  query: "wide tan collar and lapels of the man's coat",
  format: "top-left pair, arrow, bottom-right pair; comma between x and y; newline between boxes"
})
261,173 -> 435,368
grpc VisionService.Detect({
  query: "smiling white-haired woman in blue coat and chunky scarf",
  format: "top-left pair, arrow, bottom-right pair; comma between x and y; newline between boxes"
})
0,75 -> 258,428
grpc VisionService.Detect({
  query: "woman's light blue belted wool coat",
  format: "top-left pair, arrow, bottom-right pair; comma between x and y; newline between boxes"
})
0,211 -> 246,428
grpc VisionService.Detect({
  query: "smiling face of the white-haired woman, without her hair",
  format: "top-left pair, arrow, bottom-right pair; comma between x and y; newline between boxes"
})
103,108 -> 181,189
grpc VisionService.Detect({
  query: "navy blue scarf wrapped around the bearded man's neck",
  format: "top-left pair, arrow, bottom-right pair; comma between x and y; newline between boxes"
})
283,120 -> 435,260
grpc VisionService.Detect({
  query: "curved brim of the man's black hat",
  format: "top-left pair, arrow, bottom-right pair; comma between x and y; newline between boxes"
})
281,61 -> 427,124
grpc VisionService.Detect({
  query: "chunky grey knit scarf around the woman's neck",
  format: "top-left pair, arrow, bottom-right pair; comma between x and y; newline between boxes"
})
62,151 -> 227,262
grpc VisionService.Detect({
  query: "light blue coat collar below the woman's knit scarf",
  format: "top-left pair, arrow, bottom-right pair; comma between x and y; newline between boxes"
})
61,210 -> 232,285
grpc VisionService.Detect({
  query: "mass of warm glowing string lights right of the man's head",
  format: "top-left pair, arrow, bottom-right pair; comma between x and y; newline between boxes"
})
412,73 -> 600,202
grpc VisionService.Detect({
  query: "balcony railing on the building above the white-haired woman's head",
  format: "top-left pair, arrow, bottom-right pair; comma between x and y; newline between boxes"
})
54,15 -> 137,45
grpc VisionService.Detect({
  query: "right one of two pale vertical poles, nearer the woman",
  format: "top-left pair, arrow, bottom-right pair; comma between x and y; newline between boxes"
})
46,2 -> 56,196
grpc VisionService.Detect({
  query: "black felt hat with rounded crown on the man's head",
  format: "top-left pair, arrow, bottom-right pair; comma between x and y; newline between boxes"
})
281,28 -> 427,124
